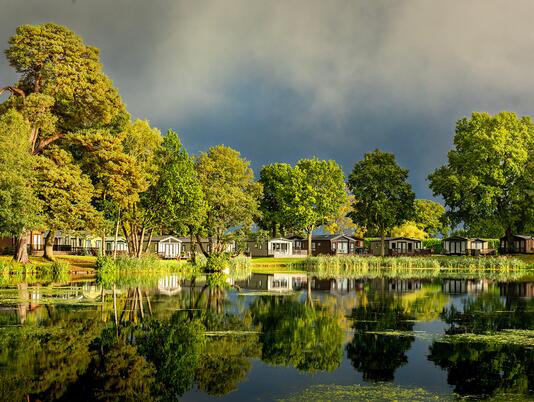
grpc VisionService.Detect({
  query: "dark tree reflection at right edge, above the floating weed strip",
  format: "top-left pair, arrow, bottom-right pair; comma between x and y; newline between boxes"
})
441,292 -> 534,334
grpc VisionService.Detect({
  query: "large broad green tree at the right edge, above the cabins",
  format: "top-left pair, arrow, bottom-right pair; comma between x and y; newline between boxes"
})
428,112 -> 534,244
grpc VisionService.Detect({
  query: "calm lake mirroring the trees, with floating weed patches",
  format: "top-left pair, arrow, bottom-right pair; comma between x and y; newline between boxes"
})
0,273 -> 534,401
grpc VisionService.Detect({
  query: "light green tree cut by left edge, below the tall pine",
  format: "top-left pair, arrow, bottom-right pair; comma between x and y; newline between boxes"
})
0,109 -> 41,262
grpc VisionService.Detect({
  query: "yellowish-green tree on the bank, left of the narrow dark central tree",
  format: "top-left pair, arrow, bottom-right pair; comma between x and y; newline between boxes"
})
195,145 -> 262,256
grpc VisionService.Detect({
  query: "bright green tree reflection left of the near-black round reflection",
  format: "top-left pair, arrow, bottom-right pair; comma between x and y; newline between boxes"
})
250,297 -> 343,371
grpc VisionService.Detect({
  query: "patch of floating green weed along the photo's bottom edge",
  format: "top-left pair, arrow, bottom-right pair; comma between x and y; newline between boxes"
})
281,383 -> 455,402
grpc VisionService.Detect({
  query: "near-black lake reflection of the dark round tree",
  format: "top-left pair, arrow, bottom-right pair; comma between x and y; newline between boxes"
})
347,292 -> 414,381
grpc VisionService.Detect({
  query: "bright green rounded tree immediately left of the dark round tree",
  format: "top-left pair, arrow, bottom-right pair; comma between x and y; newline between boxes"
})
283,158 -> 347,255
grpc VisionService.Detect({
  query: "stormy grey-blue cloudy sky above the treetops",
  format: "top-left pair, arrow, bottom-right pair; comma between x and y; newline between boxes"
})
0,0 -> 534,198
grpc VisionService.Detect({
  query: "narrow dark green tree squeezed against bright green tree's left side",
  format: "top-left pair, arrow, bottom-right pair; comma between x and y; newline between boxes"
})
258,163 -> 292,237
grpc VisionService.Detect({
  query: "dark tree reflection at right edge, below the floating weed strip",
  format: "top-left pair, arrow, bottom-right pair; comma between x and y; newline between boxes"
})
429,342 -> 534,396
